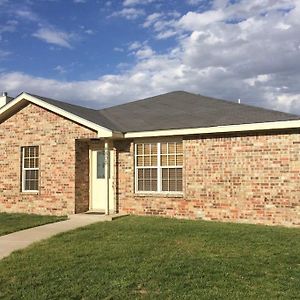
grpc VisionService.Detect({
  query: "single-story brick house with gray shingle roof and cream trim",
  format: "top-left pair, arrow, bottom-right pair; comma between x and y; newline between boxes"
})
0,92 -> 300,226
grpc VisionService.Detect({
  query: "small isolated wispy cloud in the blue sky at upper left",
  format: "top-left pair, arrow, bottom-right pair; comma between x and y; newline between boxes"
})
33,27 -> 73,48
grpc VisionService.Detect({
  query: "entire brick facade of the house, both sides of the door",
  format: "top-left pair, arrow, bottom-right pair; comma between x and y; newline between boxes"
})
0,104 -> 300,226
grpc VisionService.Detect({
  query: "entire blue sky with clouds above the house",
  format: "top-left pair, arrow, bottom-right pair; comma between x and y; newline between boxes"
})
0,0 -> 300,114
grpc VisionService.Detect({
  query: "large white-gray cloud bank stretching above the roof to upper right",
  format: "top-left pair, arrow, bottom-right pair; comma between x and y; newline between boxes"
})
0,0 -> 300,113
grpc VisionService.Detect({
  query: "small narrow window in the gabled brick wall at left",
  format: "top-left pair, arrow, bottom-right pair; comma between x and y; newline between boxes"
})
22,146 -> 39,192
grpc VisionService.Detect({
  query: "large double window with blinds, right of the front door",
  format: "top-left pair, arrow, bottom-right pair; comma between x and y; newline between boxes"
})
135,142 -> 183,192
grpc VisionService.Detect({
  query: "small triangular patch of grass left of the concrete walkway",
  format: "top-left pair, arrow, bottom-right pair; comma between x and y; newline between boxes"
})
0,213 -> 67,236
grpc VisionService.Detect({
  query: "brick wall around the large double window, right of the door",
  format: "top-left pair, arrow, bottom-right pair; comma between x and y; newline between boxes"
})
118,133 -> 300,226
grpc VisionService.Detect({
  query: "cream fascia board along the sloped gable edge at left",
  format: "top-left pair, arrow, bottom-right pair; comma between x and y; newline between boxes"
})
0,93 -> 113,137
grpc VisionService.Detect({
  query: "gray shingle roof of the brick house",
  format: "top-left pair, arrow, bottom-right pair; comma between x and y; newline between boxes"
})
25,91 -> 300,132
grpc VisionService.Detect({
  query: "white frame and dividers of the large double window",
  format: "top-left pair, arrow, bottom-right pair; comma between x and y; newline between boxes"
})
134,140 -> 183,195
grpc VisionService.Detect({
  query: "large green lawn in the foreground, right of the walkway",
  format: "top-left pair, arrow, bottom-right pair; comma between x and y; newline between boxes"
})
0,217 -> 300,299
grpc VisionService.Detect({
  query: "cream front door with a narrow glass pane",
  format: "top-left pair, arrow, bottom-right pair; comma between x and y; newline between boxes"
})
90,147 -> 115,213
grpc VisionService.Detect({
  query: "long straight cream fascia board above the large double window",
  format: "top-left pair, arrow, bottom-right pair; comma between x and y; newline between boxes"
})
124,120 -> 300,138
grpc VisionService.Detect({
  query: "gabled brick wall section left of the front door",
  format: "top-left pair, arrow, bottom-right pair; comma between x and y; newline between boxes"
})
0,104 -> 96,215
